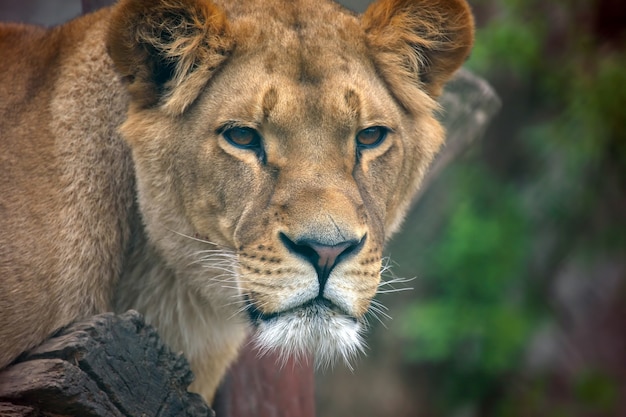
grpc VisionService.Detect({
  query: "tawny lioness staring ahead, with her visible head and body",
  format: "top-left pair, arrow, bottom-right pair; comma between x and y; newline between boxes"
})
0,0 -> 473,401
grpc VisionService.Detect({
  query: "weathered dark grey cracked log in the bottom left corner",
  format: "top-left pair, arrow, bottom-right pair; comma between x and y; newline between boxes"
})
0,311 -> 214,417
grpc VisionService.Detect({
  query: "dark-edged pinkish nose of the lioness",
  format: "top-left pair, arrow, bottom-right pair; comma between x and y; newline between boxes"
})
280,233 -> 365,296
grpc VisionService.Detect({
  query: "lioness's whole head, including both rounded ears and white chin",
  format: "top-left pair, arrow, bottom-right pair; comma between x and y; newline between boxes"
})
109,1 -> 471,361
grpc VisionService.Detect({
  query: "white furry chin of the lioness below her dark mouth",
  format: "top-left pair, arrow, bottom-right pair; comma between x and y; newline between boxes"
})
249,298 -> 365,370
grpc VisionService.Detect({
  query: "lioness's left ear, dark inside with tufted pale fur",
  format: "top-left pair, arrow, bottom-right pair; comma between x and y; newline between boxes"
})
106,0 -> 233,114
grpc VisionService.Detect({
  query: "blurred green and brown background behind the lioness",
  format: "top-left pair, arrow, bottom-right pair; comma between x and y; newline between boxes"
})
0,0 -> 626,417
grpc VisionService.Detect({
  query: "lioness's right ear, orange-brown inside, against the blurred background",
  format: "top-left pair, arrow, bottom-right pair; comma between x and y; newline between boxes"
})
361,0 -> 474,97
